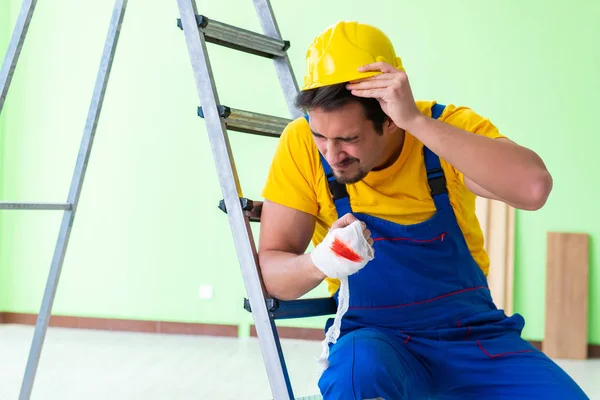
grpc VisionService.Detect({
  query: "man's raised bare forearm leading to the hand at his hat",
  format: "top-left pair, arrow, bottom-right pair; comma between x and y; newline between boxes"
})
406,117 -> 552,209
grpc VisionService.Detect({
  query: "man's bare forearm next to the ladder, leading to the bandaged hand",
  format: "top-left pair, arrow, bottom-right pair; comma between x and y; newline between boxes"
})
259,250 -> 326,300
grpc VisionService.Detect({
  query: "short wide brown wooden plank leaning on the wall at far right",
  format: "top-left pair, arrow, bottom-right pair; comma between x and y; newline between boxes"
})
542,232 -> 589,359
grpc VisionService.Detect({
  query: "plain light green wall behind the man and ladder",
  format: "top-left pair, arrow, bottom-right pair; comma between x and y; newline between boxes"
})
0,0 -> 600,343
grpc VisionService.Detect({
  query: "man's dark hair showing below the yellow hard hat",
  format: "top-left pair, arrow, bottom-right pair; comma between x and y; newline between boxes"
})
296,83 -> 387,135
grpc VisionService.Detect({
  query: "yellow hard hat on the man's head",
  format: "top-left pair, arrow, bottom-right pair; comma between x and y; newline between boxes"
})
302,21 -> 404,90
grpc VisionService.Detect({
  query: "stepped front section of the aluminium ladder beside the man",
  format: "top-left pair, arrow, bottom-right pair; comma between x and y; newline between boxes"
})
177,0 -> 336,400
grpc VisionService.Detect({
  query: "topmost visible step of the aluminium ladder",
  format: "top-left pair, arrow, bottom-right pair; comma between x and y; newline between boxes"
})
177,15 -> 290,58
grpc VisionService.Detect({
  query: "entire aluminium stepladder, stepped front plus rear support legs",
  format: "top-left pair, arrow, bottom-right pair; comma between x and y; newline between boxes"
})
0,0 -> 336,400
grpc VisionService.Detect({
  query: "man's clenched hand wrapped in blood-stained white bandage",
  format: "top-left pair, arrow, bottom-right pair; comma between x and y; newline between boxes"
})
311,214 -> 375,278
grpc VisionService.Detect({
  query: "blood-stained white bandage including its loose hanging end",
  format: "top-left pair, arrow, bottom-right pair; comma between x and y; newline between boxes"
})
311,221 -> 375,372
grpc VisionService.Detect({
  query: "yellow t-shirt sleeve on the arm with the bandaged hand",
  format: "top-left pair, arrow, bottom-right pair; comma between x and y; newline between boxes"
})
262,119 -> 318,216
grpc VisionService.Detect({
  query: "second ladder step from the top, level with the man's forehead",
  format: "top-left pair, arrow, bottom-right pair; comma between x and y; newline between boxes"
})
198,105 -> 291,138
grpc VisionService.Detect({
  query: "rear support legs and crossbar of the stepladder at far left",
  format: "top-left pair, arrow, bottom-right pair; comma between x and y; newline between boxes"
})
0,0 -> 127,400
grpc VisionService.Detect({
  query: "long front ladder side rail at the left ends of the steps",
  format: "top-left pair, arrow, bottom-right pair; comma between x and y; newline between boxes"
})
177,0 -> 294,400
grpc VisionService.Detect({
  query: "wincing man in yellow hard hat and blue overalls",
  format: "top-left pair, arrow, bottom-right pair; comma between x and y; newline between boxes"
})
259,22 -> 587,400
